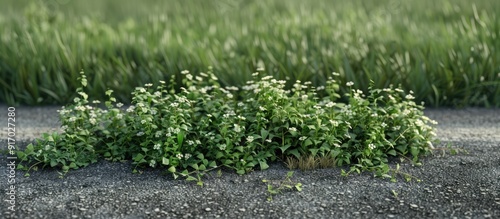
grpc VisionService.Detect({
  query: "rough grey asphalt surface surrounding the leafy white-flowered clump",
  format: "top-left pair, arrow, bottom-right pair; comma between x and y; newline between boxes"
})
0,105 -> 500,218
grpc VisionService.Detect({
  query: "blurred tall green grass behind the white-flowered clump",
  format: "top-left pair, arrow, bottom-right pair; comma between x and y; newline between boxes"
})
0,0 -> 500,107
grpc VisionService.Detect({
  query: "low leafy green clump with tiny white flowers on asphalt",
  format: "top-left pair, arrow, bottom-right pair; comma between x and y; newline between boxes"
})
18,68 -> 435,181
